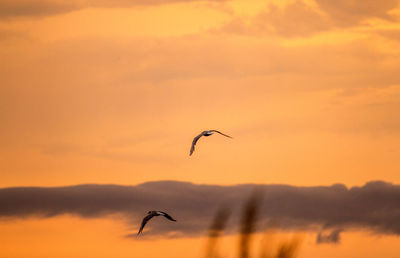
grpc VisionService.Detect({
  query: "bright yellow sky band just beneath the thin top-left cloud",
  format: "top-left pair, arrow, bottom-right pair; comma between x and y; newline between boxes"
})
0,1 -> 276,42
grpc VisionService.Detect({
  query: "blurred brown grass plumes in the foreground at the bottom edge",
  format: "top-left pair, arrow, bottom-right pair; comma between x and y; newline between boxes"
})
205,192 -> 300,258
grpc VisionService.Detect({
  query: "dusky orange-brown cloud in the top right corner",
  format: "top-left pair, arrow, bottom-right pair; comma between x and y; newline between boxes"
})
214,0 -> 399,37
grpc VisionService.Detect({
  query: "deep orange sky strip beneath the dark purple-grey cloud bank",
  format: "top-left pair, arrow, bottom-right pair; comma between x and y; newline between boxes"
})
0,216 -> 400,258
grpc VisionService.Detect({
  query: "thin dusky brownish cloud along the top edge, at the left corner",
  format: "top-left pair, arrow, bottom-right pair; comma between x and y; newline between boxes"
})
0,0 -> 224,19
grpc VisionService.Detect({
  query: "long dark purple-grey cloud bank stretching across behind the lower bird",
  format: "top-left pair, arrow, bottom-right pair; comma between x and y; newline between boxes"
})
0,181 -> 400,238
